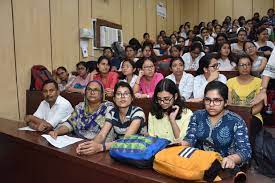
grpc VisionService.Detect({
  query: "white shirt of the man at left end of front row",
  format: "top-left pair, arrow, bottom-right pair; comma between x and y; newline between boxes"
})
33,96 -> 74,128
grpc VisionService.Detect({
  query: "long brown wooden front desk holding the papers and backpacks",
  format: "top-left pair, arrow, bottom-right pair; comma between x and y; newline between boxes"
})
0,118 -> 268,183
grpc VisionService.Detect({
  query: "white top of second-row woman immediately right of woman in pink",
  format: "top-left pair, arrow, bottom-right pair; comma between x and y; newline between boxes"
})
166,72 -> 194,100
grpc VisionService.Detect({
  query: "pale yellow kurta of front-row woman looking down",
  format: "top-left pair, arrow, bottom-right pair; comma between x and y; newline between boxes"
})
148,109 -> 193,143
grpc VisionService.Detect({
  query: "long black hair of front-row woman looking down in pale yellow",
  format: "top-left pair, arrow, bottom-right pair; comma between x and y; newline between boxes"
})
151,79 -> 185,120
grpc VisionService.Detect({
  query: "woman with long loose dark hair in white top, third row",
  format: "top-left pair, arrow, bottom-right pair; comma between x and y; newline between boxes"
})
217,42 -> 236,71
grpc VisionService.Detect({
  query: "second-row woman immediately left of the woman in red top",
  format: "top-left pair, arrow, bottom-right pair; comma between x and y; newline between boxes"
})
66,61 -> 91,94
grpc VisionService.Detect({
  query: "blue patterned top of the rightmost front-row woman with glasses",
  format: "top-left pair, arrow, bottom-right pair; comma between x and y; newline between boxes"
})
185,109 -> 251,163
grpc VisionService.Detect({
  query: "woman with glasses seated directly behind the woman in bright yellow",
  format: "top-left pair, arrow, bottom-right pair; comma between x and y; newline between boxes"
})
243,41 -> 267,77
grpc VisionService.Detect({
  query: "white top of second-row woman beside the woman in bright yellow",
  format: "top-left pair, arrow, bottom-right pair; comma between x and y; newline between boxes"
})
193,74 -> 227,98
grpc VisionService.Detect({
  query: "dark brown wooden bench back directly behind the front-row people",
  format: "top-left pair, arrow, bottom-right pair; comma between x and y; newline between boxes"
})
26,90 -> 252,134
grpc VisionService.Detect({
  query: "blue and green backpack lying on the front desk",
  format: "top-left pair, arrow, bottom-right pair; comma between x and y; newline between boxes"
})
110,135 -> 170,168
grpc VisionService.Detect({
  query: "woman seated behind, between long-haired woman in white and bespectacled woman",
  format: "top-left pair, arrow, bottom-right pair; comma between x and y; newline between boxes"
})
230,27 -> 247,55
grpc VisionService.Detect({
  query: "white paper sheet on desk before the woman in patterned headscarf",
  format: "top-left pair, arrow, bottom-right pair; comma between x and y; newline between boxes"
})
41,134 -> 83,148
